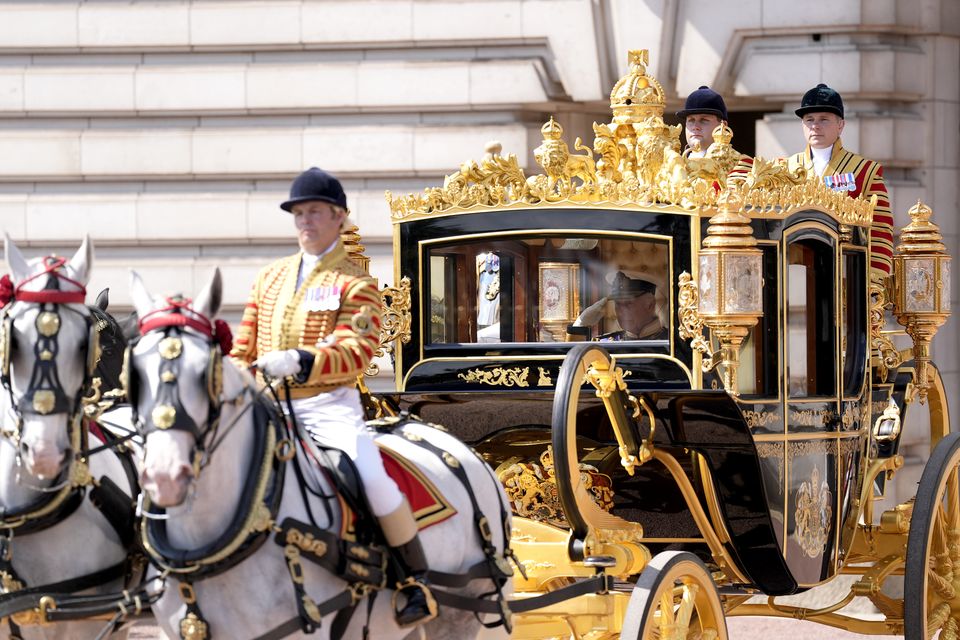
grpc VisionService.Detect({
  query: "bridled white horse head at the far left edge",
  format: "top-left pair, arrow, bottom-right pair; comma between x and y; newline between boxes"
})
0,236 -> 100,480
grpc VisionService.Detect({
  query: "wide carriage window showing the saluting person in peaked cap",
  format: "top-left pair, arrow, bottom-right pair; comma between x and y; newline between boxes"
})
424,233 -> 671,344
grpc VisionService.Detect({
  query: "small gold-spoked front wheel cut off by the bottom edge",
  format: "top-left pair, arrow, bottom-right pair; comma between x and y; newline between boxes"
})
620,551 -> 727,640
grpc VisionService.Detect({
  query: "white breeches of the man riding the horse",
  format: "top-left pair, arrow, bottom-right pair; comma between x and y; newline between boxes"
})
293,387 -> 403,518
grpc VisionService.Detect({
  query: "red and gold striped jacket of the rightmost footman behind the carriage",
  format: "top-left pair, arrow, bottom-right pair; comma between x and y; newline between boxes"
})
787,140 -> 893,279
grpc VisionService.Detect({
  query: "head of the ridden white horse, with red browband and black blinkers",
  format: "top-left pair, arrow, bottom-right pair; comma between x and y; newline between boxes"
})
126,269 -> 234,508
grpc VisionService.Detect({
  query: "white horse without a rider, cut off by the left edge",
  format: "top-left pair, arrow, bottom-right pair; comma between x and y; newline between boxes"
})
0,237 -> 137,639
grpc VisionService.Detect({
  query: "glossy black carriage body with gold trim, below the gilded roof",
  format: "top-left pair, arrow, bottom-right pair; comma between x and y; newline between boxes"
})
388,205 -> 894,594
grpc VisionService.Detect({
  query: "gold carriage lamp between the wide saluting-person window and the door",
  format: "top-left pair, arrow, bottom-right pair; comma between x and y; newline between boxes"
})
698,191 -> 763,396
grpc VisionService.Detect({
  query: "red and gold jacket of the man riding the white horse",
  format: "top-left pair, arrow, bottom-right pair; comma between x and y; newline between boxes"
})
230,242 -> 381,398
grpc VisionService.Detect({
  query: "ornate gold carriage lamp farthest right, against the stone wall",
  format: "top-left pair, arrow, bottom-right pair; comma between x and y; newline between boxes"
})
893,200 -> 950,404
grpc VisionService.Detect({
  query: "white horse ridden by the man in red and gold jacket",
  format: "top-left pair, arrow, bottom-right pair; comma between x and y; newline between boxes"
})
130,271 -> 510,640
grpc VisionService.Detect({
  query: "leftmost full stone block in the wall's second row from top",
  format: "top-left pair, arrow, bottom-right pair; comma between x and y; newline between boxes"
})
24,66 -> 135,112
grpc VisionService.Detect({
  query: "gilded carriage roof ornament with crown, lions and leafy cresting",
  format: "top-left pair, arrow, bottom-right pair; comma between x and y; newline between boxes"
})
386,49 -> 875,226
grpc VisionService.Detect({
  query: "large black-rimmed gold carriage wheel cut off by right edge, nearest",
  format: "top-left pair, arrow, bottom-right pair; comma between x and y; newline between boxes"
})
903,433 -> 960,640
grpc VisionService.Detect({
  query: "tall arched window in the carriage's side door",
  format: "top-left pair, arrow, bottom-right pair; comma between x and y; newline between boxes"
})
787,239 -> 836,397
